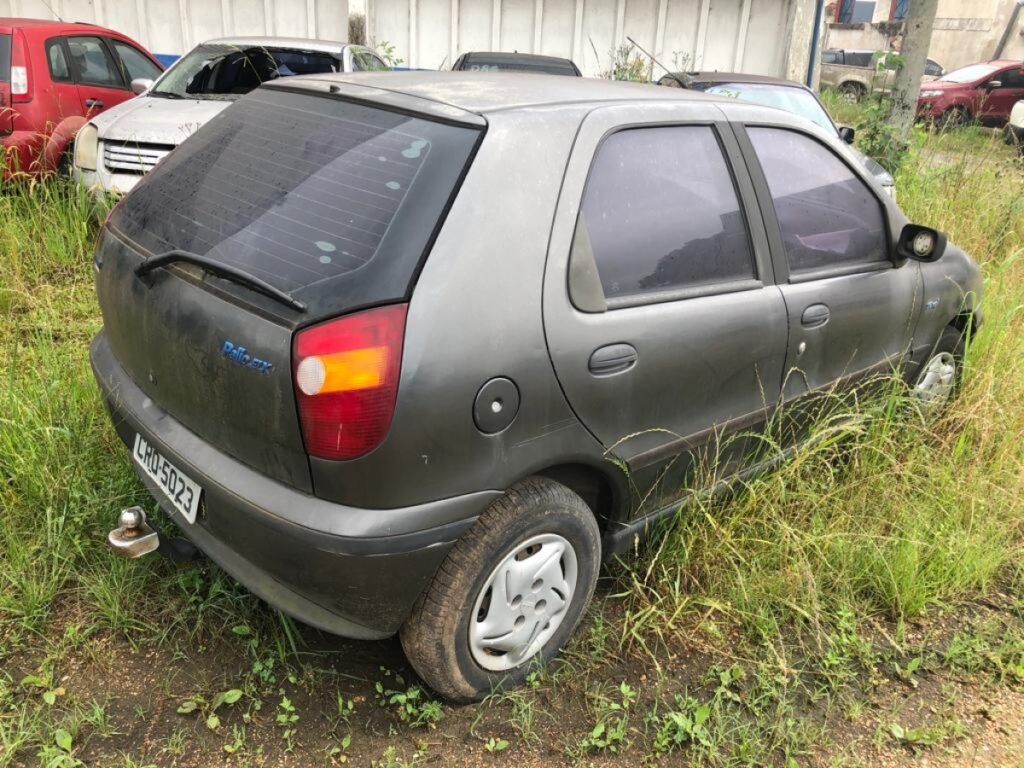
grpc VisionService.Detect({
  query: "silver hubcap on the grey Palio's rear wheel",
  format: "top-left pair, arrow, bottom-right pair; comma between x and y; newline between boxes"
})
469,534 -> 577,672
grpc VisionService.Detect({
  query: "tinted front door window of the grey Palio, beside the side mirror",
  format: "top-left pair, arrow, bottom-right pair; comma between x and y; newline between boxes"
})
748,128 -> 889,273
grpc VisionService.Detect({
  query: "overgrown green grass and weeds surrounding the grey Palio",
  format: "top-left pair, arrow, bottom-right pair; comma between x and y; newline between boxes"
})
0,123 -> 1024,768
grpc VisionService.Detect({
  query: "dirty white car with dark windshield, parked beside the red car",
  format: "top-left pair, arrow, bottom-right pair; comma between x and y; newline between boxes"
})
74,37 -> 390,194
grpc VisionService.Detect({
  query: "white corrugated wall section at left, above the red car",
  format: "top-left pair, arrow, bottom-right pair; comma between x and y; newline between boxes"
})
0,0 -> 348,55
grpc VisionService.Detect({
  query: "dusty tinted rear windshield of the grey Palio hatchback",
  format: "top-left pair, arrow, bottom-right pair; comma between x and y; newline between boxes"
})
111,88 -> 479,292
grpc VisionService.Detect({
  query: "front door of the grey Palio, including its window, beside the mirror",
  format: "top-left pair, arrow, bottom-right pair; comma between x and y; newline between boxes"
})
739,124 -> 922,415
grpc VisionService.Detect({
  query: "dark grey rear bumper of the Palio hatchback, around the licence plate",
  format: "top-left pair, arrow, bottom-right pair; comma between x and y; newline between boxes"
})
90,333 -> 494,639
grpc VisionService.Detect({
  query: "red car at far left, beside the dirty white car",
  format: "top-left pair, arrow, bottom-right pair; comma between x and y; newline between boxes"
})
0,17 -> 163,179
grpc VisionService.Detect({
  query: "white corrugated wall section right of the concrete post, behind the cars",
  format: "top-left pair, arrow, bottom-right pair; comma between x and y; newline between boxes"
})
367,0 -> 802,76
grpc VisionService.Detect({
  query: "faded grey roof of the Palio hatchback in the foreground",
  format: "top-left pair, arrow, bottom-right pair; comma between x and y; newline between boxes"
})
280,71 -> 720,115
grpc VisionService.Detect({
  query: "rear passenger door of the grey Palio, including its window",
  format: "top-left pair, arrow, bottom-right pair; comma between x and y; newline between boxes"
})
544,103 -> 786,514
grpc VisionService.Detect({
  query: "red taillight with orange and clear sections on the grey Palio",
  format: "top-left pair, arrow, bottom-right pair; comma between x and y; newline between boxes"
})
292,304 -> 408,459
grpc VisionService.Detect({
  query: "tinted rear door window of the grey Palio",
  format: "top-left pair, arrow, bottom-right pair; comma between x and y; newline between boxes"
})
573,126 -> 755,306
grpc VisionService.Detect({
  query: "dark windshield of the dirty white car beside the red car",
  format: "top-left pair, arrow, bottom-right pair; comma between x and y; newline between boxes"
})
150,45 -> 341,99
